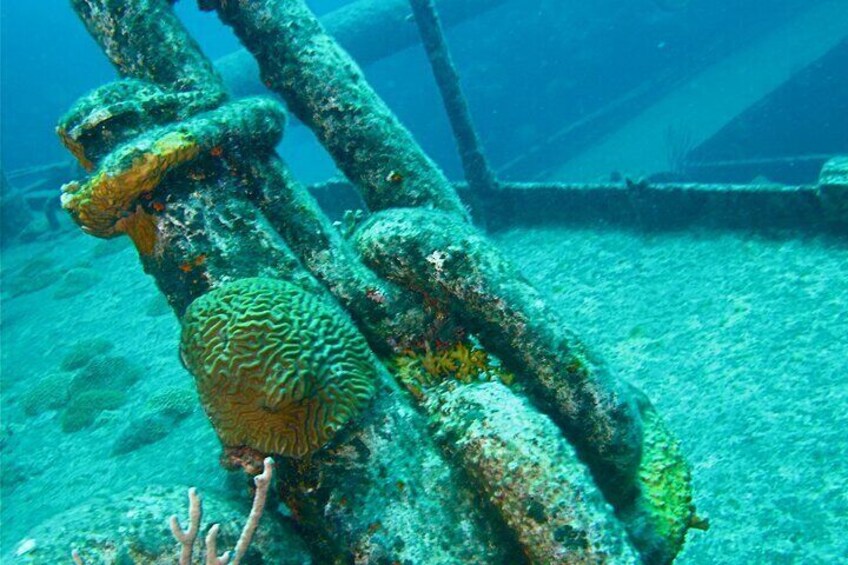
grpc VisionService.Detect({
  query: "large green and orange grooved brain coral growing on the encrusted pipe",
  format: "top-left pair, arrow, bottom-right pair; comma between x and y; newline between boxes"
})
180,278 -> 377,457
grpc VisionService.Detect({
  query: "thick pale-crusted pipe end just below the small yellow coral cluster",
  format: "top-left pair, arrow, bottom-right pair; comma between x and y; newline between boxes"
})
424,382 -> 640,564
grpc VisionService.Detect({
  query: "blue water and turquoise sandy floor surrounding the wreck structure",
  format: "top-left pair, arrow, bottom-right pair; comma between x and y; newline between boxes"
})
0,0 -> 848,564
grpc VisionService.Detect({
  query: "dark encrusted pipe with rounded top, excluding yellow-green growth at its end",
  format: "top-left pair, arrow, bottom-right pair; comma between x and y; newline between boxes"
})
356,209 -> 642,505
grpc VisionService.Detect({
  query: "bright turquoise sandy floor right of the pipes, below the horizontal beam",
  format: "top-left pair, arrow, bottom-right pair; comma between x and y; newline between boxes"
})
498,229 -> 848,564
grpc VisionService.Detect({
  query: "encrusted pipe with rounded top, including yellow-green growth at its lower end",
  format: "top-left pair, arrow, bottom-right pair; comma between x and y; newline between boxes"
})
356,209 -> 699,563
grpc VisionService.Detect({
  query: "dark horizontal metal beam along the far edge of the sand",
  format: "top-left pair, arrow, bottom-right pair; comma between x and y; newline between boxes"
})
309,176 -> 839,231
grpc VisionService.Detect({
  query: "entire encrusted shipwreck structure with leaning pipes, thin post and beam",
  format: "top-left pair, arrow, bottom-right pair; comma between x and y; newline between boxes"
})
53,0 -> 848,564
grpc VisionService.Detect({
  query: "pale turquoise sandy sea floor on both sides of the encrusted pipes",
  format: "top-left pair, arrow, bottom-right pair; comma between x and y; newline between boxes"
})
0,223 -> 848,564
